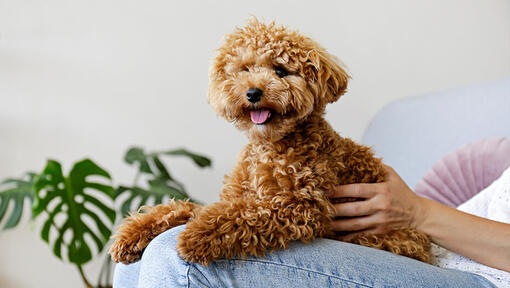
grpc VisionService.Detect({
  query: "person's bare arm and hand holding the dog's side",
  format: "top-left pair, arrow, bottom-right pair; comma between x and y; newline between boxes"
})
329,166 -> 510,272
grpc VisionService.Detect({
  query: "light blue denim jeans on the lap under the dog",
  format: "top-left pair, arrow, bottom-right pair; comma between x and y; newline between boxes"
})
113,226 -> 495,288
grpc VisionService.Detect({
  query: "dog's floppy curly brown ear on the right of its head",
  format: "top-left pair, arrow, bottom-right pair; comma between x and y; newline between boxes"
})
305,49 -> 350,105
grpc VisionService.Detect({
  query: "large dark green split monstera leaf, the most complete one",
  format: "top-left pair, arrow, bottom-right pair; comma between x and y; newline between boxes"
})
32,159 -> 116,265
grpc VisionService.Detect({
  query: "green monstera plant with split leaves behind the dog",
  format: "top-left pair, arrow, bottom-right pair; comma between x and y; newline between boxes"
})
0,147 -> 211,287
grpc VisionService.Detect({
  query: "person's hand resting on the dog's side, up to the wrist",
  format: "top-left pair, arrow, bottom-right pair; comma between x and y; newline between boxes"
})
328,165 -> 424,241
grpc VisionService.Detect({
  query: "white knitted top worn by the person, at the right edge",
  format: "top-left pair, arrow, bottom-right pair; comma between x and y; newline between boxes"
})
432,167 -> 510,288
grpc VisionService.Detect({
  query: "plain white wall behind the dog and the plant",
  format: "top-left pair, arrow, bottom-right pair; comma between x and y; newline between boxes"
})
0,0 -> 510,287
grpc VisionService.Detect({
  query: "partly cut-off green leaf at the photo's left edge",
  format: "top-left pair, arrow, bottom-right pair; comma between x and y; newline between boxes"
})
0,173 -> 35,230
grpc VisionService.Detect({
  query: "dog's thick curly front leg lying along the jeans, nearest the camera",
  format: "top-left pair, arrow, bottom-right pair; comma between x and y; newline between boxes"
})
177,197 -> 331,265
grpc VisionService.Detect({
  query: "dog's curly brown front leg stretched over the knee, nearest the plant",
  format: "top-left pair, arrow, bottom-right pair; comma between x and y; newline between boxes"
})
109,200 -> 201,264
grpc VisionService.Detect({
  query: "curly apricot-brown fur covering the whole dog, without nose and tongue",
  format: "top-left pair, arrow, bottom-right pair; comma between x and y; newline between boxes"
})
110,19 -> 430,265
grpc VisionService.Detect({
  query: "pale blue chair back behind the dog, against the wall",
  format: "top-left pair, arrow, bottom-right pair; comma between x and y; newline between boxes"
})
362,78 -> 510,187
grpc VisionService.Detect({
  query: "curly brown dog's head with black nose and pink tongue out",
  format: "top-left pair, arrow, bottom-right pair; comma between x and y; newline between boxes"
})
208,19 -> 349,142
